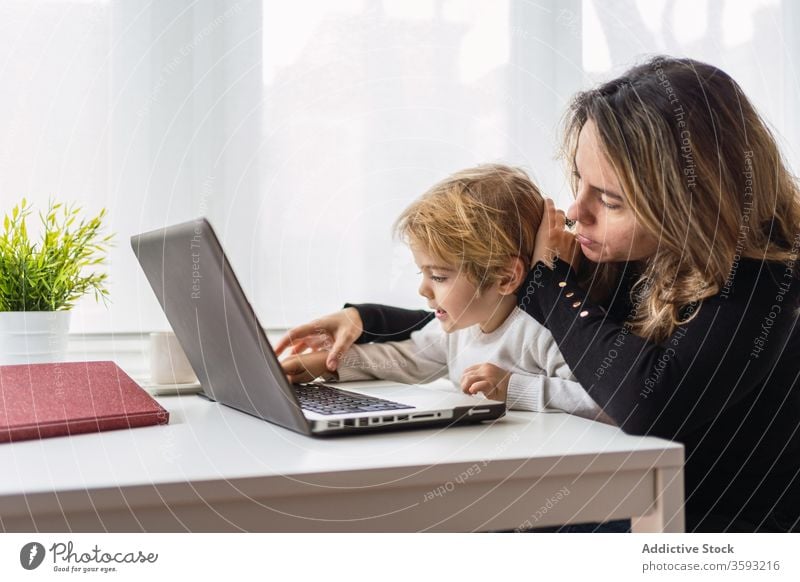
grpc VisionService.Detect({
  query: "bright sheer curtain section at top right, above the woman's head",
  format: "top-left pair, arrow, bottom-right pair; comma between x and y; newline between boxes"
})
581,0 -> 800,170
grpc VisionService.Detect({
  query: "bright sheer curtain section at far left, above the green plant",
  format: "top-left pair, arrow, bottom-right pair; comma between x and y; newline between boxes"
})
0,1 -> 113,324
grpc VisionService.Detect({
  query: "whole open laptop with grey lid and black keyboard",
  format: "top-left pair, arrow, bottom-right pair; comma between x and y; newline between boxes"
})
131,218 -> 506,436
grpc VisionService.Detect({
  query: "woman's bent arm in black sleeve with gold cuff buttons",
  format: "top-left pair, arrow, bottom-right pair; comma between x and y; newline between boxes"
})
518,260 -> 800,438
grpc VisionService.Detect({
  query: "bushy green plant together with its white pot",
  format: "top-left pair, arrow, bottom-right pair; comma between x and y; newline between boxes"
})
0,198 -> 113,364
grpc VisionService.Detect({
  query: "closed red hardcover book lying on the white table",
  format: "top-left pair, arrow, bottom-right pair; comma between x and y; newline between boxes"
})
0,362 -> 169,443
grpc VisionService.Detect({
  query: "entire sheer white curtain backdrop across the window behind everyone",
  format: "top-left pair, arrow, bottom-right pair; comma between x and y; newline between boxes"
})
0,0 -> 800,332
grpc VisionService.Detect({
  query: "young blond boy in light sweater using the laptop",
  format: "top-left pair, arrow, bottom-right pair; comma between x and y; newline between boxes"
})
282,164 -> 612,423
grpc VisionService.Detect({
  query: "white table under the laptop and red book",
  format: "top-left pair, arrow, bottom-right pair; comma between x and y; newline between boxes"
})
0,380 -> 684,532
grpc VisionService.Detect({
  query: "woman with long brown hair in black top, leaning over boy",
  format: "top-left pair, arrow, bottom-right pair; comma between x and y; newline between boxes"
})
278,57 -> 800,531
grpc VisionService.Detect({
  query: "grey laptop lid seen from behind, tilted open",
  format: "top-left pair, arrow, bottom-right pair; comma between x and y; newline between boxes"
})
131,218 -> 310,434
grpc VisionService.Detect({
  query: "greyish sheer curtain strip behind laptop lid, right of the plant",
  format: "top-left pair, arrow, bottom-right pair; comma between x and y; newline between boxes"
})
108,0 -> 263,330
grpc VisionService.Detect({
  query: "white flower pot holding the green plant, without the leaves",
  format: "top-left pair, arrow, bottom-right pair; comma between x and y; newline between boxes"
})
0,311 -> 72,364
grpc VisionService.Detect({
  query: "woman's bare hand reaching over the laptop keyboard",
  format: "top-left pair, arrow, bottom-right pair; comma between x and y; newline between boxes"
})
275,307 -> 364,372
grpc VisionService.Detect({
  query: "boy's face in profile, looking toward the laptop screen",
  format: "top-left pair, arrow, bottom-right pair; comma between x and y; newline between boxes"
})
411,245 -> 507,333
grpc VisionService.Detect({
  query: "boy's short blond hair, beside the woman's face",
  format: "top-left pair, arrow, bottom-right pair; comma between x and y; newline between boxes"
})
395,164 -> 544,289
